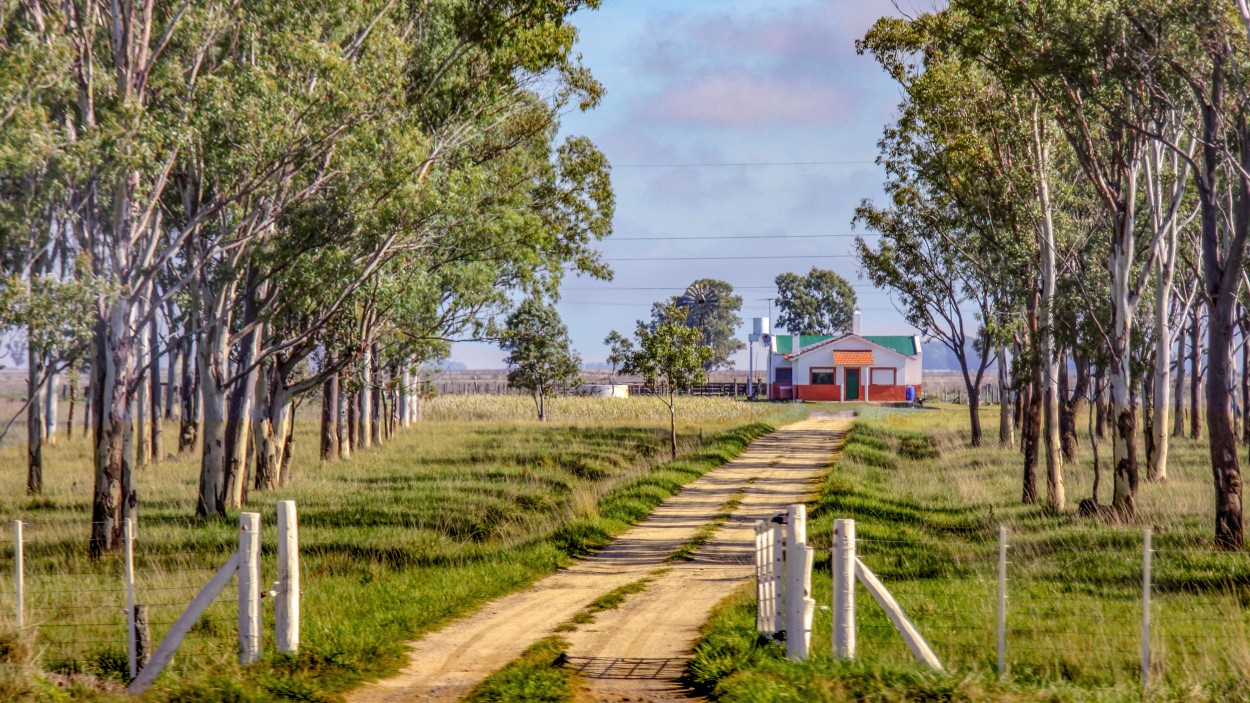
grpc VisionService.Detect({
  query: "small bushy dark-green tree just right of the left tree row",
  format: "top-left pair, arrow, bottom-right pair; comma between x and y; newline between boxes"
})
500,298 -> 581,420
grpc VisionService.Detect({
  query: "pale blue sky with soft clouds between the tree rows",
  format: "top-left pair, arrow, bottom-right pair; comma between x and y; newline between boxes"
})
451,0 -> 915,369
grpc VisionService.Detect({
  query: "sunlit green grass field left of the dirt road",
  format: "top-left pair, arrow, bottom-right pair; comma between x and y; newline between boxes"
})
0,398 -> 804,703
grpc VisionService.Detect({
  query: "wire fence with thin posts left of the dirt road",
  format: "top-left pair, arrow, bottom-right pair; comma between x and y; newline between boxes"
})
0,519 -> 245,682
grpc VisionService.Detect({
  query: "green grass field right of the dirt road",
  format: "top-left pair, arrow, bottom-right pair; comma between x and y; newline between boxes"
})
690,408 -> 1250,702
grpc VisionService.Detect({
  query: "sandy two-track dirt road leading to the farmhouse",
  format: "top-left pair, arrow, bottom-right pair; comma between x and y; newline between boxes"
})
349,418 -> 850,703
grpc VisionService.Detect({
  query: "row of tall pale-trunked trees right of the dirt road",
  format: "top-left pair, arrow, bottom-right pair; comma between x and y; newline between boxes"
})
856,0 -> 1250,548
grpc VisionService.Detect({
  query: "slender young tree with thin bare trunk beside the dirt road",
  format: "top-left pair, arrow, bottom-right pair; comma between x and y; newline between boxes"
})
621,305 -> 713,459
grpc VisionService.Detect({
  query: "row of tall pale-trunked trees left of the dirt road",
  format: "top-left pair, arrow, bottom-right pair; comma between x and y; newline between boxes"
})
0,0 -> 613,554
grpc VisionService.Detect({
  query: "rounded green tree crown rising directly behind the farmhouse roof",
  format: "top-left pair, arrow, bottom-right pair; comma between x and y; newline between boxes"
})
776,266 -> 856,334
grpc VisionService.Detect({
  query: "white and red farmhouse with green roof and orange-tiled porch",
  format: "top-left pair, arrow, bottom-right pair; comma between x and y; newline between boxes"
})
769,310 -> 923,403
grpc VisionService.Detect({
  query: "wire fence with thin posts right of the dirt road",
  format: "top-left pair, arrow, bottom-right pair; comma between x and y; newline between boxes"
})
780,530 -> 1250,687
